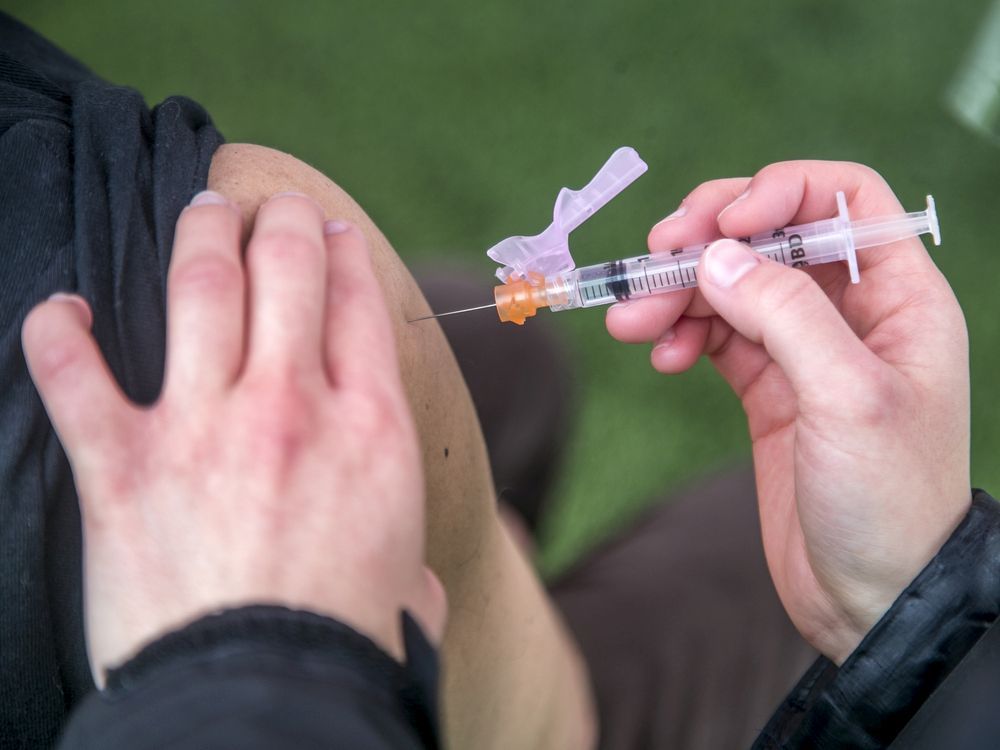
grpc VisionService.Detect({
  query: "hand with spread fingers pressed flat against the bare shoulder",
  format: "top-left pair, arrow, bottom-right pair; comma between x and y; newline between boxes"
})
23,193 -> 445,684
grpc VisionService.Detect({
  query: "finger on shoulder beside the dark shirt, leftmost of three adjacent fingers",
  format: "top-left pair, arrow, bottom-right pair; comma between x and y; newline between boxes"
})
166,191 -> 245,393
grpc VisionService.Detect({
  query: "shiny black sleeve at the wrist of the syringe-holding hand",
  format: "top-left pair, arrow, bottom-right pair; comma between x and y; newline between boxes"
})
754,490 -> 1000,750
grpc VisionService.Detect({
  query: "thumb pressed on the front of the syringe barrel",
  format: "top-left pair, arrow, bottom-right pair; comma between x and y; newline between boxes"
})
698,240 -> 877,400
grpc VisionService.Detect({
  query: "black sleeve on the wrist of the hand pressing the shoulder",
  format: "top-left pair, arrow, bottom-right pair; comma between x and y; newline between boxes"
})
59,606 -> 438,750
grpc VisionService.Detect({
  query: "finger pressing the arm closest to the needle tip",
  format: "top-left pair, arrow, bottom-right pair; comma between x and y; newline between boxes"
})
325,220 -> 399,388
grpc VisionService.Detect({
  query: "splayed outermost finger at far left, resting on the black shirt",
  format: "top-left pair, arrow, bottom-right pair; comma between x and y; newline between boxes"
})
21,295 -> 133,465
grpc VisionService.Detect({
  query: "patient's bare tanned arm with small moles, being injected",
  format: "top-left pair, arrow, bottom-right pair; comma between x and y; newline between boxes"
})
208,144 -> 594,750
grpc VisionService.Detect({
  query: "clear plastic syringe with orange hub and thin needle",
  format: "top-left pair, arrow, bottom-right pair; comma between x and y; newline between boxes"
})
410,193 -> 941,325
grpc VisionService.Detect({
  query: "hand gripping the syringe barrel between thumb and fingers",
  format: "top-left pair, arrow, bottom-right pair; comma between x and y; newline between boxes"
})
607,162 -> 970,663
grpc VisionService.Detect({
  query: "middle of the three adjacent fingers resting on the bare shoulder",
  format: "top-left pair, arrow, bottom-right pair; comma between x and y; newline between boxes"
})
246,193 -> 326,372
